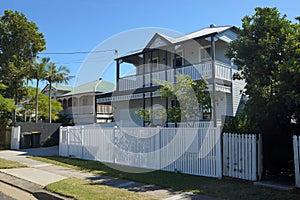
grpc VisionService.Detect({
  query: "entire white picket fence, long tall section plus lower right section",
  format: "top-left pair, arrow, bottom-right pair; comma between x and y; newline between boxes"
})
59,126 -> 262,181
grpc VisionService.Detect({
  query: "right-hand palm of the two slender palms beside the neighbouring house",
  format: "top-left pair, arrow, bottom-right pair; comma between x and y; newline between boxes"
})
45,62 -> 70,123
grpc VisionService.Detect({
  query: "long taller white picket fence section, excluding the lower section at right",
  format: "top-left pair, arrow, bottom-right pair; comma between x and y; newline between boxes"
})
59,126 -> 222,178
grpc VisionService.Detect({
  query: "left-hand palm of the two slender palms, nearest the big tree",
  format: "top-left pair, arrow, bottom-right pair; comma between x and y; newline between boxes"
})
31,58 -> 50,123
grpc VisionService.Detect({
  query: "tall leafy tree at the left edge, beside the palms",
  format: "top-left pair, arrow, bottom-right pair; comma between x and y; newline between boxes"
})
0,10 -> 46,125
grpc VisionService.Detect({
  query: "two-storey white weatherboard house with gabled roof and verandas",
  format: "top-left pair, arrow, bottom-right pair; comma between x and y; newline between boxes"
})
97,25 -> 245,126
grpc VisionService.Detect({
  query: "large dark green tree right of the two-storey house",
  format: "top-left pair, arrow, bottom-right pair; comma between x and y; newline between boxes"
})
227,8 -> 300,132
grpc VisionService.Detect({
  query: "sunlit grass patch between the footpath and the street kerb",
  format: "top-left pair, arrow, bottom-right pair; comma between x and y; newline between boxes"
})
46,178 -> 155,200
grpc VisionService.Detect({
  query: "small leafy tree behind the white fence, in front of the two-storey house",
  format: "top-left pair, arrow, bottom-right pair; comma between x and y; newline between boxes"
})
135,74 -> 211,126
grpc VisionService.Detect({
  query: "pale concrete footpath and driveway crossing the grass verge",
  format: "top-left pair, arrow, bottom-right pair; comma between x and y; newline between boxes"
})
0,146 -> 220,200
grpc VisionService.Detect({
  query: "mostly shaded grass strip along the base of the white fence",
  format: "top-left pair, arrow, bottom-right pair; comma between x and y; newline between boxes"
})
33,157 -> 300,200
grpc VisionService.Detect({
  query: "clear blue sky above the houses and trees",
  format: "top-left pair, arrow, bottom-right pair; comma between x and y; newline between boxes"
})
0,0 -> 300,84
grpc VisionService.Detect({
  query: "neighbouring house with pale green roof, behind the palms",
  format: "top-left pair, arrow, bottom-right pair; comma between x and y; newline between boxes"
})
42,79 -> 115,124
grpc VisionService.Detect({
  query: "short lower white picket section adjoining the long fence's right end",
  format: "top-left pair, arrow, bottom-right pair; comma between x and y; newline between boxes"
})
223,133 -> 262,181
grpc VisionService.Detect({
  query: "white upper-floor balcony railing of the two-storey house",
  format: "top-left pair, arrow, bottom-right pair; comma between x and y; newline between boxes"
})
118,61 -> 232,91
